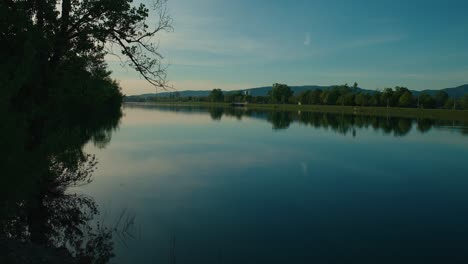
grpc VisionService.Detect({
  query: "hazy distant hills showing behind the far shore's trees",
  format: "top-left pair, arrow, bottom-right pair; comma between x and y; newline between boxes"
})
125,84 -> 468,102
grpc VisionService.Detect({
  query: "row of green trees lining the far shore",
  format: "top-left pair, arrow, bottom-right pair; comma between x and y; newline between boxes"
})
155,83 -> 468,109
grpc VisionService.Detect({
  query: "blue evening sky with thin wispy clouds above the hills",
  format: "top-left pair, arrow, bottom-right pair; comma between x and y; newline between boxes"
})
109,0 -> 468,95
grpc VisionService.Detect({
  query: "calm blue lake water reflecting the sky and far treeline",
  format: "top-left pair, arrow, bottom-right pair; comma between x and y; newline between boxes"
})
77,104 -> 468,263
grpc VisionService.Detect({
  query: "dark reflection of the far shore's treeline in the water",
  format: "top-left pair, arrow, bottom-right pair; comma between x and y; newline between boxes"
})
126,104 -> 468,137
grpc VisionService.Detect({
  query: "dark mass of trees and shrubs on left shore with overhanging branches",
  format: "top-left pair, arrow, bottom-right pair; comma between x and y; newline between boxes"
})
0,0 -> 171,263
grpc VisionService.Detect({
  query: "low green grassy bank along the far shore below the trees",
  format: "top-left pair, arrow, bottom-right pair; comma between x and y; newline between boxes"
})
146,102 -> 468,121
